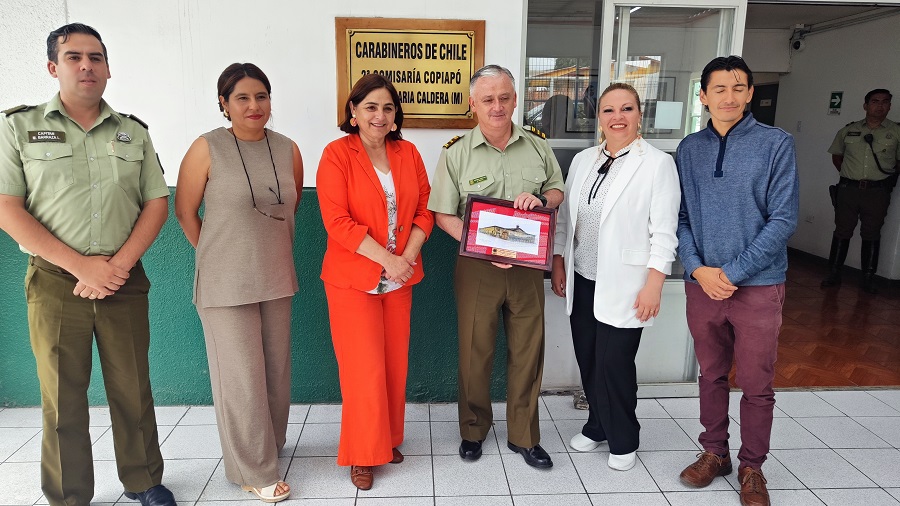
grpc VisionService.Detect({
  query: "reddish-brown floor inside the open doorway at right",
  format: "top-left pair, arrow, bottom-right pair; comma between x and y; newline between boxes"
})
731,252 -> 900,388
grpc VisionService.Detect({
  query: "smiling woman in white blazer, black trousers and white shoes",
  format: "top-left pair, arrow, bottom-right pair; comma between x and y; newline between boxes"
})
551,83 -> 681,471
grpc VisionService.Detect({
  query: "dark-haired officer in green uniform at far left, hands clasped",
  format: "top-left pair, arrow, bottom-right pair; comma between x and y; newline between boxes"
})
0,23 -> 175,506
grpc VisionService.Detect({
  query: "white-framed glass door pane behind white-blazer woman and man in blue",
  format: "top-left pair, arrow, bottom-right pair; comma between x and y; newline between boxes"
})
597,0 -> 747,152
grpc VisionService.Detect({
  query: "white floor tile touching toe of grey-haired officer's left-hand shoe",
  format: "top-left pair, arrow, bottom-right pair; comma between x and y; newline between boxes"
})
434,455 -> 510,496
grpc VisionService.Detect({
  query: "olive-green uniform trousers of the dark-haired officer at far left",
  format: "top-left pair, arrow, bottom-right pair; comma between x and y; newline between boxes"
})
25,257 -> 163,506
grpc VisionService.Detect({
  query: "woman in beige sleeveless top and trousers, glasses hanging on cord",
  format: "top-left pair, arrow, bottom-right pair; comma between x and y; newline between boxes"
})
175,63 -> 303,502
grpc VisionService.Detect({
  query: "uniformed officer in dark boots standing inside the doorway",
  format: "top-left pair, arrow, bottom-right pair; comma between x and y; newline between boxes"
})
822,88 -> 900,293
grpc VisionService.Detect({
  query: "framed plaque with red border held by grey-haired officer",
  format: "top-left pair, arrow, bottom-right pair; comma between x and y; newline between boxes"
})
459,195 -> 556,271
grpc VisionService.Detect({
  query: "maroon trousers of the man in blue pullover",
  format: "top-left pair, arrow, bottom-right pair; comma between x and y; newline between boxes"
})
684,282 -> 784,469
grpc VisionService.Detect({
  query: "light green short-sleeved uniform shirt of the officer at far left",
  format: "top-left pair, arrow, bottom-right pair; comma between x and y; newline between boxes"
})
0,94 -> 169,256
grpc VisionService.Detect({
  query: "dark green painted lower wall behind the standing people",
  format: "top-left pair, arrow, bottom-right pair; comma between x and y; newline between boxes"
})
0,188 -> 506,406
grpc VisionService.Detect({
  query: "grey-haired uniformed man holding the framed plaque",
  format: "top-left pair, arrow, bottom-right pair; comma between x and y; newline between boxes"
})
428,65 -> 565,468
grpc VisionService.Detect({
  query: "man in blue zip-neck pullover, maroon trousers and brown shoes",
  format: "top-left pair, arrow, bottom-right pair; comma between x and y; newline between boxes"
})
675,56 -> 798,505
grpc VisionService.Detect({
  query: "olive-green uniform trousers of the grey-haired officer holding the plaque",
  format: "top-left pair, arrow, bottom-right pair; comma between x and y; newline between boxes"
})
455,257 -> 544,448
